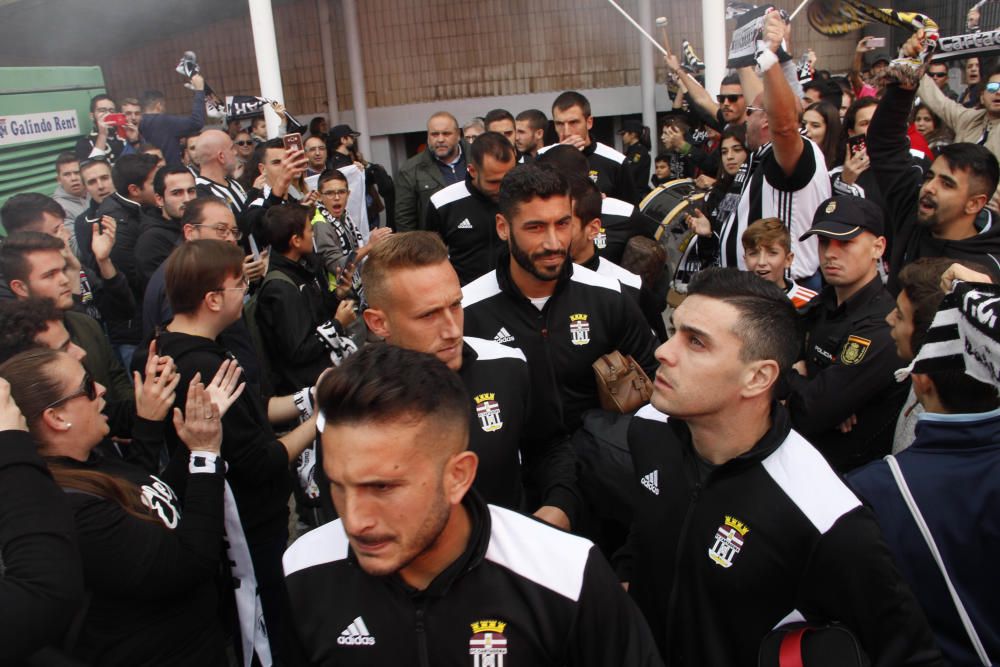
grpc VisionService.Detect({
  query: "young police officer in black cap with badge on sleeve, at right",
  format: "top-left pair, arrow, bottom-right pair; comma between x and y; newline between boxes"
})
787,196 -> 907,473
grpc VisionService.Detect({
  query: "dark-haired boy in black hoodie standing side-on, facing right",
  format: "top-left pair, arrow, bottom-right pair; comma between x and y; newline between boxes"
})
257,203 -> 357,394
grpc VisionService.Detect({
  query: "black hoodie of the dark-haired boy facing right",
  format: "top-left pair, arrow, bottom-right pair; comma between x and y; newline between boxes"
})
256,253 -> 351,395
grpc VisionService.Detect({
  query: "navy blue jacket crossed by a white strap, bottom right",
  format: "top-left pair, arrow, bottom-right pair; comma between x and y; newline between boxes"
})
847,410 -> 1000,665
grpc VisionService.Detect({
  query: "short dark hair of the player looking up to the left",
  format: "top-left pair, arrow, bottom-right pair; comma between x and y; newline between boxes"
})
688,267 -> 799,372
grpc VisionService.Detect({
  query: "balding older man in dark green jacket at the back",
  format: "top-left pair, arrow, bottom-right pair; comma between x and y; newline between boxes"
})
396,111 -> 468,232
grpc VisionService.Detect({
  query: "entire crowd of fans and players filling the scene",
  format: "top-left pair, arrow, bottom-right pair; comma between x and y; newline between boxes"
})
0,12 -> 1000,666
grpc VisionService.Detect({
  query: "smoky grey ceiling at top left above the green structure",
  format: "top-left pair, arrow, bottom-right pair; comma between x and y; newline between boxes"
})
0,0 -> 288,65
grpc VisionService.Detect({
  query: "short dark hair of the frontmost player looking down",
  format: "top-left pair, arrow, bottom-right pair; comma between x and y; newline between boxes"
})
316,343 -> 471,444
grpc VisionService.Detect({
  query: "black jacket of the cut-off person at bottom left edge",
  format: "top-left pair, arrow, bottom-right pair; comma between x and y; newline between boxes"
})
0,431 -> 83,665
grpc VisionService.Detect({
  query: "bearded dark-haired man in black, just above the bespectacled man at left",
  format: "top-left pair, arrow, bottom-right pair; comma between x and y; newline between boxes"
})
135,166 -> 198,294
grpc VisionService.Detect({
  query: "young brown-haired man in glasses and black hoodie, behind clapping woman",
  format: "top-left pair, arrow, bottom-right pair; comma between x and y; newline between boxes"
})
157,239 -> 316,661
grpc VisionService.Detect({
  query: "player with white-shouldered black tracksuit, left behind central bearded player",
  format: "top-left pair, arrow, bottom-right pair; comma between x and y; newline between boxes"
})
427,132 -> 516,285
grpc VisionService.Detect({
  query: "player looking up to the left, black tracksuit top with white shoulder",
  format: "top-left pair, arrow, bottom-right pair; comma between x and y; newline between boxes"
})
618,268 -> 941,665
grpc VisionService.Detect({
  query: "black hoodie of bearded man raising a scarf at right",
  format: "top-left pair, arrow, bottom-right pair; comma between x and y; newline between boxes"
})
868,85 -> 1000,294
